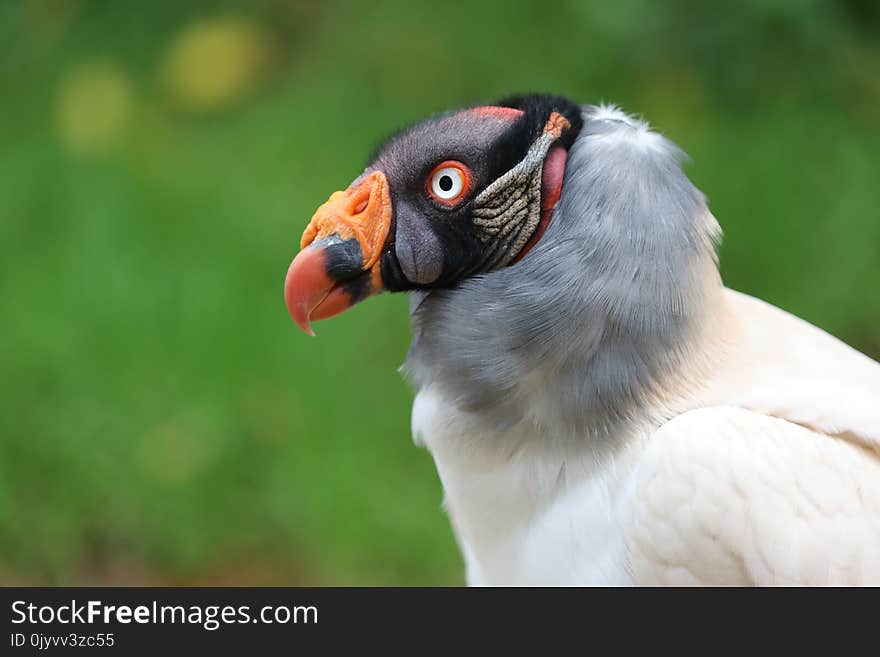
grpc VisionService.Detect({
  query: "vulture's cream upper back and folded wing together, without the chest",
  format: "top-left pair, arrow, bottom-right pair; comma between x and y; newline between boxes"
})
628,290 -> 880,584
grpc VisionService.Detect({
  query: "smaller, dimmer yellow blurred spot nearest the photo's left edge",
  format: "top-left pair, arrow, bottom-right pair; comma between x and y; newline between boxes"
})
57,60 -> 133,155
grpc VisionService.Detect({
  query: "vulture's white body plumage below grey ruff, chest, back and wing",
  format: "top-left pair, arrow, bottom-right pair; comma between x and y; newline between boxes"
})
413,290 -> 880,585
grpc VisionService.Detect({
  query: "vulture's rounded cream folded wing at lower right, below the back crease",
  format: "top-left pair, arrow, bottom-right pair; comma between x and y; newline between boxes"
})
626,406 -> 880,585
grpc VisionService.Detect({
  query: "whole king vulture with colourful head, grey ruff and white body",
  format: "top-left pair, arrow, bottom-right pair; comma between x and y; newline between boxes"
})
285,95 -> 880,585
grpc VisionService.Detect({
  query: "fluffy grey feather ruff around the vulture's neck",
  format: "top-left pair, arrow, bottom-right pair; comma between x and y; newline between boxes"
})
403,106 -> 720,438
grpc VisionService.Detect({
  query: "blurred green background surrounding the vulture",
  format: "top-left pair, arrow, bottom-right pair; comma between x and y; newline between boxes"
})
0,0 -> 880,585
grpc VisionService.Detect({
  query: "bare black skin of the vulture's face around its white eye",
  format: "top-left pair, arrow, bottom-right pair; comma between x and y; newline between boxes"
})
367,95 -> 583,291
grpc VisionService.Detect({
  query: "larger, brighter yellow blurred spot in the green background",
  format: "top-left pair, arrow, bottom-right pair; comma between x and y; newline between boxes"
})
164,17 -> 271,110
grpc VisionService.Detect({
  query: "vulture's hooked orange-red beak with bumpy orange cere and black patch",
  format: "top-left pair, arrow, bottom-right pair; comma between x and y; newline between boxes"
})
284,171 -> 391,335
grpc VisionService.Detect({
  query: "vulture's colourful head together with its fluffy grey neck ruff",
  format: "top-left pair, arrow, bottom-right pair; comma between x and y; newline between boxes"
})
284,95 -> 720,436
